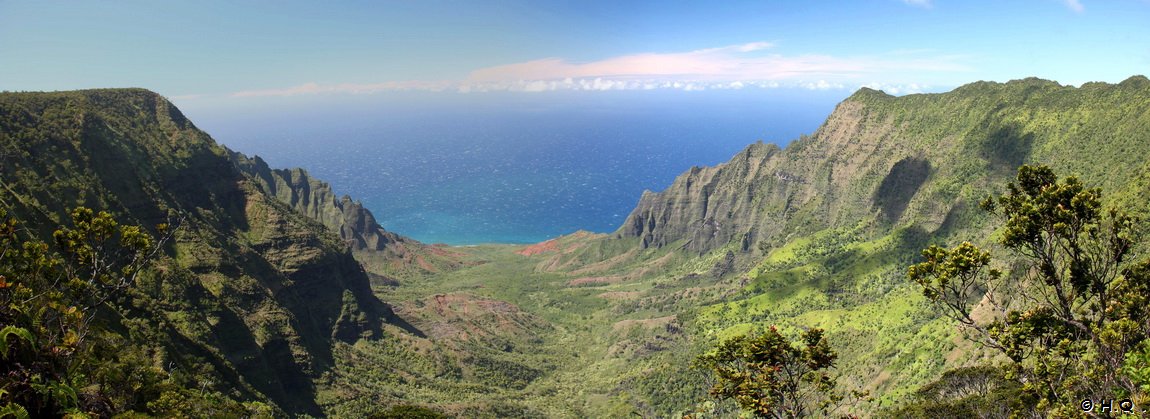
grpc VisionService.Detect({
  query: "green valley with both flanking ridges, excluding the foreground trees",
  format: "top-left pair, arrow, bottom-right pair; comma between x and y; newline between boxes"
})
0,76 -> 1150,417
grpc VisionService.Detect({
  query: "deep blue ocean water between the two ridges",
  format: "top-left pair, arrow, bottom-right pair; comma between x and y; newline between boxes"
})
190,91 -> 844,244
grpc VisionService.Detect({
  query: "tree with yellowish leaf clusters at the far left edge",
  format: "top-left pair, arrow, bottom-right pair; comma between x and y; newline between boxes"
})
0,207 -> 170,417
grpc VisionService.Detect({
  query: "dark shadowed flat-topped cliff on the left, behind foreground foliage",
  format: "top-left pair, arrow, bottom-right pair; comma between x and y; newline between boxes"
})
0,90 -> 393,414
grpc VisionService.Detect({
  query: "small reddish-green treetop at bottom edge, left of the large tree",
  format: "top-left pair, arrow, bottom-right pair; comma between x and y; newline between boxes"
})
696,326 -> 843,418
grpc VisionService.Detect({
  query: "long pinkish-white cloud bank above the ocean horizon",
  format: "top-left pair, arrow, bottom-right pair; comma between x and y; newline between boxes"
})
231,41 -> 973,97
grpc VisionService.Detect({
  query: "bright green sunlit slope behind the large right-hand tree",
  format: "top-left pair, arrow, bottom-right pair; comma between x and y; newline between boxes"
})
680,77 -> 1150,405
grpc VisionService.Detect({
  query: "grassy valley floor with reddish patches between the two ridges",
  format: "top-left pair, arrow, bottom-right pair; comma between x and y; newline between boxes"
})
321,237 -> 708,417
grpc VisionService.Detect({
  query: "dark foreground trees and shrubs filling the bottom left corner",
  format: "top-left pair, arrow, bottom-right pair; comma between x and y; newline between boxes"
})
0,207 -> 270,418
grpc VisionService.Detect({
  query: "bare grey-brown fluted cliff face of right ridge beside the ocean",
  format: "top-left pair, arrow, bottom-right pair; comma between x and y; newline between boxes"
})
620,92 -> 930,253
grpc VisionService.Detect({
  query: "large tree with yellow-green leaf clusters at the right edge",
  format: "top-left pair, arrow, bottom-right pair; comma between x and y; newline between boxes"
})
909,166 -> 1150,413
